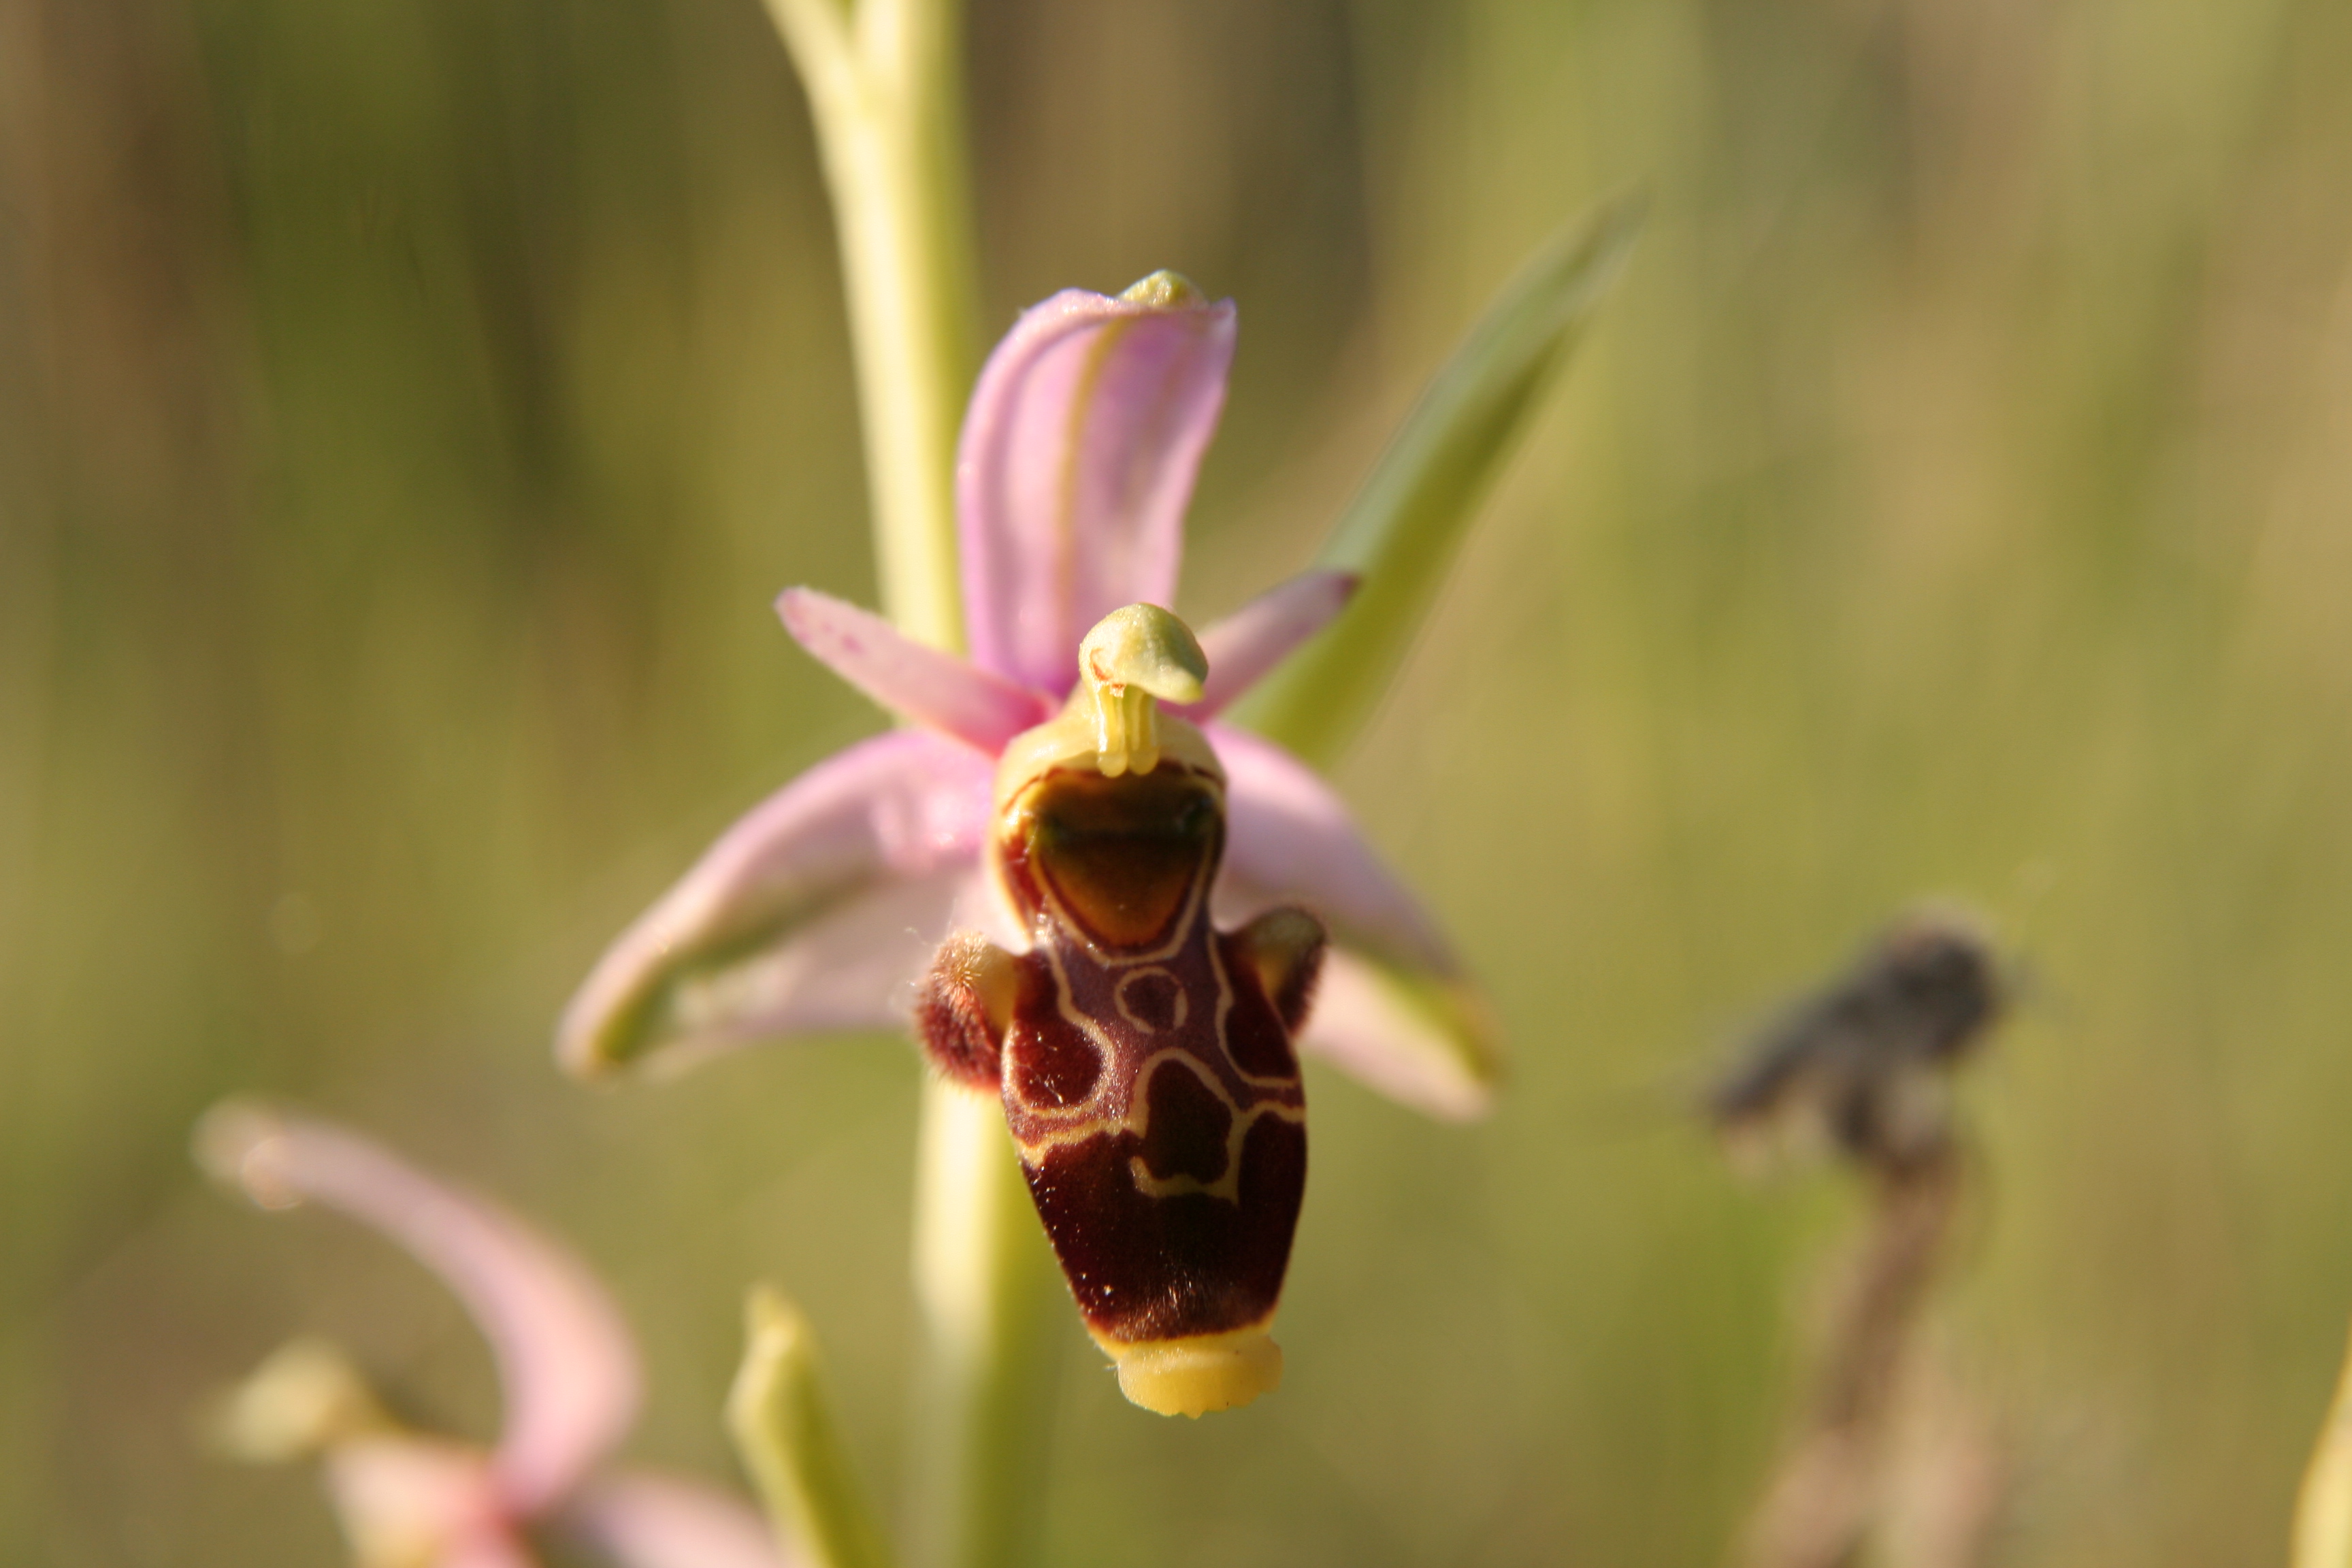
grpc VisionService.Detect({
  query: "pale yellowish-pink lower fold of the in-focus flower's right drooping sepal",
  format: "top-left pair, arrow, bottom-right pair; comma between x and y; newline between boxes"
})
1298,947 -> 1496,1122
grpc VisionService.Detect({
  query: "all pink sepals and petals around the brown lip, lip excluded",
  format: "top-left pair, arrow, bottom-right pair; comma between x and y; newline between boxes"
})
557,273 -> 1491,1117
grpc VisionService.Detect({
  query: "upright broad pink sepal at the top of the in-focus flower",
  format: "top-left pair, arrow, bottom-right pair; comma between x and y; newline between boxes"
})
955,289 -> 1232,696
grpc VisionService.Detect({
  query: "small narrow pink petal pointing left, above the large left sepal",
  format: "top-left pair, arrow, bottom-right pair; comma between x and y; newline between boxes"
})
776,588 -> 1054,755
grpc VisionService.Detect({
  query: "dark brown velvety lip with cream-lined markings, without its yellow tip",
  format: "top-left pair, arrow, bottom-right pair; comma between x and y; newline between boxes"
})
997,762 -> 1308,1345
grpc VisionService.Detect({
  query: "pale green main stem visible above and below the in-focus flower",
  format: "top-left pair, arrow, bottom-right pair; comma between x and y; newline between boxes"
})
767,0 -> 1051,1568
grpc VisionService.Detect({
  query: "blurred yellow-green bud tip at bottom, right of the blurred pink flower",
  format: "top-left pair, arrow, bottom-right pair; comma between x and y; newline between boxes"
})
727,1286 -> 892,1568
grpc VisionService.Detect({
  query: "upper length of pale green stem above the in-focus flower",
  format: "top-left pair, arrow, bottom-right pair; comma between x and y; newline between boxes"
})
767,0 -> 979,649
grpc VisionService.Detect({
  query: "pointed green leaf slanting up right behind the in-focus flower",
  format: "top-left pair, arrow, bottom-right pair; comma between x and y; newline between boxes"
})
1232,197 -> 1642,762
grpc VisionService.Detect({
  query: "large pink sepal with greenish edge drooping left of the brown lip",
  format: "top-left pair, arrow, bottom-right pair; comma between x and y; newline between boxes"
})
557,731 -> 995,1075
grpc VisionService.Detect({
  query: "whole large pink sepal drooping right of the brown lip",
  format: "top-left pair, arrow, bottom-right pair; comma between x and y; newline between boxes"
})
1209,724 -> 1496,1119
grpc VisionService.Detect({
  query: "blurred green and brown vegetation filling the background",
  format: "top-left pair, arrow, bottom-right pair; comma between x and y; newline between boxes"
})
0,0 -> 2352,1568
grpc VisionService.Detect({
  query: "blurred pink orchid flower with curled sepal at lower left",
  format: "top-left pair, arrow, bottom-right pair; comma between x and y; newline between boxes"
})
195,1102 -> 785,1568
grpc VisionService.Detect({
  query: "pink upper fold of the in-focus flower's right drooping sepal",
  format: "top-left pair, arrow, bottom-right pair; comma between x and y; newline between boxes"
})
1209,724 -> 1456,976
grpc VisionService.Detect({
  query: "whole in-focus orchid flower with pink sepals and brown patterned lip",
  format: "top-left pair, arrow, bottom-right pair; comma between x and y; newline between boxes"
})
560,273 -> 1491,1415
